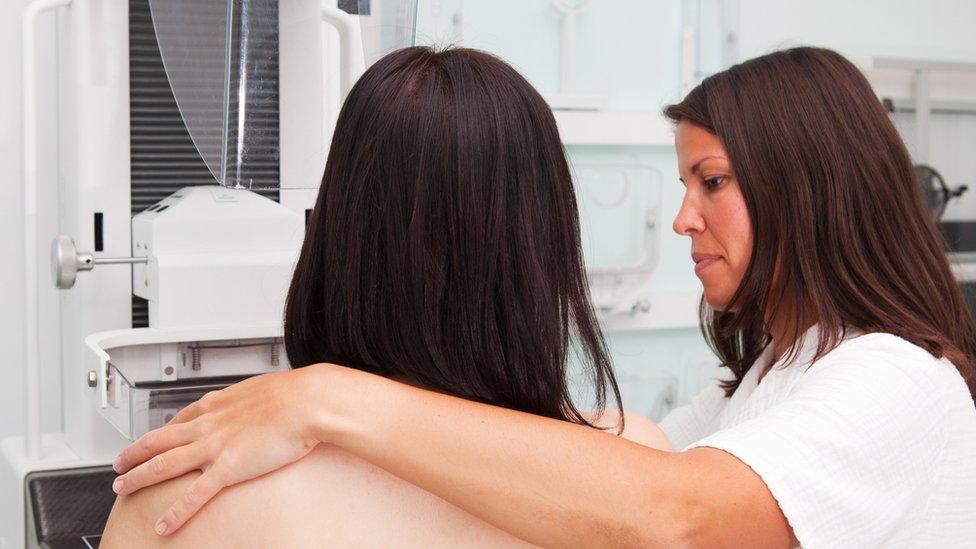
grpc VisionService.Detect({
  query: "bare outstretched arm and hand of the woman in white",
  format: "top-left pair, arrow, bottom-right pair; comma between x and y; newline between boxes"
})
113,364 -> 795,547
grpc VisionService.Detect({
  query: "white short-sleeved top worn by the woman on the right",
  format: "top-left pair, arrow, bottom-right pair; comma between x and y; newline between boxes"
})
661,326 -> 976,549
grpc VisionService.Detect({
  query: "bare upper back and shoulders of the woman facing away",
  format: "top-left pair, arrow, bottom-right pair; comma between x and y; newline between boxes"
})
102,414 -> 668,548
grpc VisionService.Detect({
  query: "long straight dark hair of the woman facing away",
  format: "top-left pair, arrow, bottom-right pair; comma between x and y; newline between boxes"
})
285,47 -> 620,424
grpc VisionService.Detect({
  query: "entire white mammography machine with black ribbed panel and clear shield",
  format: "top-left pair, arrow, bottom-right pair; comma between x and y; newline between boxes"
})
0,0 -> 424,547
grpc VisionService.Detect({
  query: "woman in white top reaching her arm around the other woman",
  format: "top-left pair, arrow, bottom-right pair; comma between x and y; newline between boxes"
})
110,48 -> 976,548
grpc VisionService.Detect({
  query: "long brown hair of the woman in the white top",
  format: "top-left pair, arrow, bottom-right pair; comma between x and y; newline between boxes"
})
664,47 -> 976,395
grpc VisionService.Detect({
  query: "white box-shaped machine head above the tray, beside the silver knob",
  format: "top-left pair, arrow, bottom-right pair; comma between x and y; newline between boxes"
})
132,185 -> 305,328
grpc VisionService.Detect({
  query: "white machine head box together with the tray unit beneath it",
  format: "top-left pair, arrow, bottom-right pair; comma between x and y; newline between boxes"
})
85,185 -> 304,440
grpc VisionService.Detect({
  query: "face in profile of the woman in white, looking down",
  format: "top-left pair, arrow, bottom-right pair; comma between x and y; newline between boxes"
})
674,122 -> 752,310
